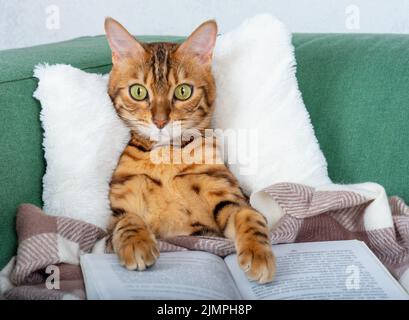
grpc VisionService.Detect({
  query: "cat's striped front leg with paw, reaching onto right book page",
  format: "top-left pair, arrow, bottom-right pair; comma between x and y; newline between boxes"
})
218,202 -> 275,283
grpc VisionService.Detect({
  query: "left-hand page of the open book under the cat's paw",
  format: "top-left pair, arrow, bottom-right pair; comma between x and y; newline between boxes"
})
81,251 -> 240,300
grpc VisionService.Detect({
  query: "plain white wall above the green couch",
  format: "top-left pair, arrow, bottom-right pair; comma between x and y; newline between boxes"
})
0,0 -> 409,50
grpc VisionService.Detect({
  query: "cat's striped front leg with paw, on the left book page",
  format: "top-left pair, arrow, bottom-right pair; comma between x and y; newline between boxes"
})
111,213 -> 159,271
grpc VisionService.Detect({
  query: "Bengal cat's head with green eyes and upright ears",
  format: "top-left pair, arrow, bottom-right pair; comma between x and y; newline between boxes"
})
105,18 -> 217,141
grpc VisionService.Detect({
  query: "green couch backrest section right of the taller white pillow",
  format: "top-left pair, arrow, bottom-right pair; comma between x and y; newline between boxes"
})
294,34 -> 409,202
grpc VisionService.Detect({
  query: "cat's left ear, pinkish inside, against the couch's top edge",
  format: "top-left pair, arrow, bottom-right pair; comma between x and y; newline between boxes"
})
105,17 -> 145,64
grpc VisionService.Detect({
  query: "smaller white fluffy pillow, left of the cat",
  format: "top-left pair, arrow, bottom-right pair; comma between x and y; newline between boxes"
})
34,65 -> 129,228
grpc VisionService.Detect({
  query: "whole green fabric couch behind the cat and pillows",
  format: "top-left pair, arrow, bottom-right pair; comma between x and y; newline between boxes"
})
0,34 -> 409,268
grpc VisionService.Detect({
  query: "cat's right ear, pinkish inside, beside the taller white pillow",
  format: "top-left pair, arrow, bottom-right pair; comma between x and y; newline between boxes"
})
177,20 -> 217,63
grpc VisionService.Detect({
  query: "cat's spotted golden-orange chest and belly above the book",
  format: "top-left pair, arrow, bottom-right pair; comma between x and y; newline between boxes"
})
115,148 -> 229,238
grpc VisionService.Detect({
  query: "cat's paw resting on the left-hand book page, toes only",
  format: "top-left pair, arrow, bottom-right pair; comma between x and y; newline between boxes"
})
115,230 -> 159,271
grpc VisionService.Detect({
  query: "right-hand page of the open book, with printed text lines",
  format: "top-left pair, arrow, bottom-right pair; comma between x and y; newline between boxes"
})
225,240 -> 409,299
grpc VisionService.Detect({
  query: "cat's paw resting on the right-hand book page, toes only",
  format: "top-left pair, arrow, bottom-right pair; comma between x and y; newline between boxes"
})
237,241 -> 275,283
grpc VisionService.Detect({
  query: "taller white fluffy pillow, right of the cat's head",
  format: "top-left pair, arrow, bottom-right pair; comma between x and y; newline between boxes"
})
213,14 -> 330,194
